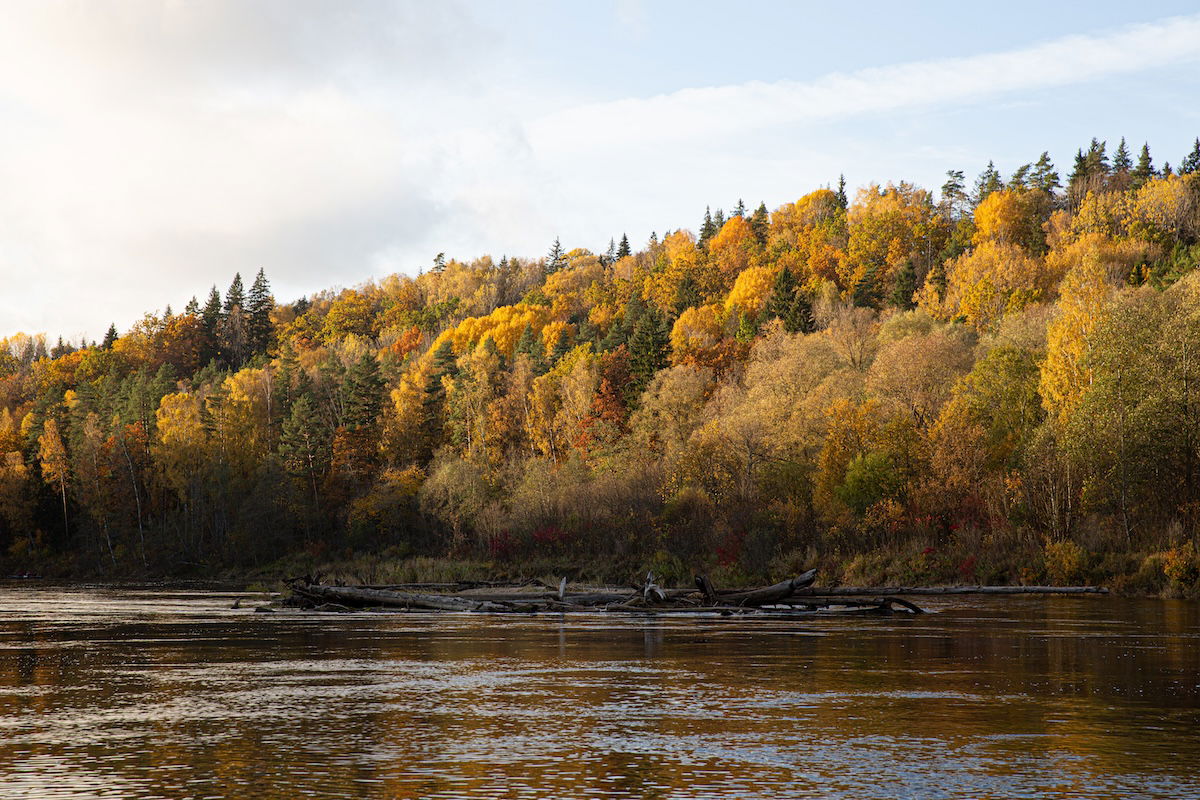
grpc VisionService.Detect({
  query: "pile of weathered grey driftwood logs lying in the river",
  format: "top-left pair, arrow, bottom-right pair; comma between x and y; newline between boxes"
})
278,570 -> 924,616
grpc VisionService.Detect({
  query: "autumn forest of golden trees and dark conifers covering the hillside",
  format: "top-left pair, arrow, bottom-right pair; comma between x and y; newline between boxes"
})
0,139 -> 1200,594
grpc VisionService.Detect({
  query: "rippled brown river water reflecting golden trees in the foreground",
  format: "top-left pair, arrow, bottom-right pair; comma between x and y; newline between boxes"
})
0,587 -> 1200,800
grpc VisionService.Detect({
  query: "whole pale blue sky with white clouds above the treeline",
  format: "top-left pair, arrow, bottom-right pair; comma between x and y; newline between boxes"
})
0,0 -> 1200,342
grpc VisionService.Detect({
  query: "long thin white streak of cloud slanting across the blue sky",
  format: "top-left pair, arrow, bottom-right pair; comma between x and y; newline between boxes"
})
530,16 -> 1200,154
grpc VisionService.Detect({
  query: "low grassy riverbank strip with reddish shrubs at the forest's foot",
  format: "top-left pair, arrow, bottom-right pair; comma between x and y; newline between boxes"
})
0,527 -> 1200,599
